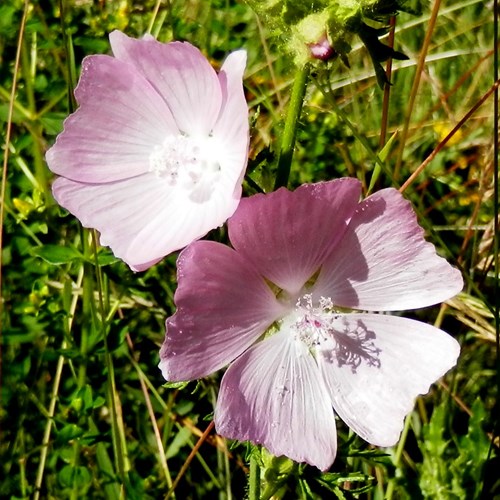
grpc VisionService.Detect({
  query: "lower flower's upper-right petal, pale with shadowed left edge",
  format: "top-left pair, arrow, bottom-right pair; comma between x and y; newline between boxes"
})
314,189 -> 463,311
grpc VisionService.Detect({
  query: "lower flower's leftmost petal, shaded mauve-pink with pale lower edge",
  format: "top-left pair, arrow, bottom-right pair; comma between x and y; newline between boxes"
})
160,241 -> 284,381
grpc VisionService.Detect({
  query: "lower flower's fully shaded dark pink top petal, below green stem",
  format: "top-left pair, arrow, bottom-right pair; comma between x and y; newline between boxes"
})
228,178 -> 361,295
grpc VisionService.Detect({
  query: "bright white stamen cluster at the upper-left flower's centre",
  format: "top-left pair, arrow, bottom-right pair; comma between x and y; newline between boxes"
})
149,134 -> 221,190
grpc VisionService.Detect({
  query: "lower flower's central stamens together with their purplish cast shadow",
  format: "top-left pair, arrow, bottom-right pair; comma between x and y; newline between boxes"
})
285,294 -> 381,372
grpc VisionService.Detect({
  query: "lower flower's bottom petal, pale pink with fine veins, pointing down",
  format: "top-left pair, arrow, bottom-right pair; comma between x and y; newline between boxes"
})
215,332 -> 337,470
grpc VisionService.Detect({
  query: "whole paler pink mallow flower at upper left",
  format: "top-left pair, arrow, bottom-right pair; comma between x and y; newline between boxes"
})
46,31 -> 249,271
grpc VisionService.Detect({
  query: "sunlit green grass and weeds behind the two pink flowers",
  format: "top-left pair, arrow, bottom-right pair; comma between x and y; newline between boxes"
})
0,0 -> 500,499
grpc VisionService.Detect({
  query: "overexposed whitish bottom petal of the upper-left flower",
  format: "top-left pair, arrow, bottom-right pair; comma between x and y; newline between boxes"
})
53,173 -> 244,271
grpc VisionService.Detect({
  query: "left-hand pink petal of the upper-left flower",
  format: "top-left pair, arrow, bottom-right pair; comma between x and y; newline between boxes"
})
46,55 -> 179,183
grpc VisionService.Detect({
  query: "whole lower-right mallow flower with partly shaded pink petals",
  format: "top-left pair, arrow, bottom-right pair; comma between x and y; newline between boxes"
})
160,178 -> 463,470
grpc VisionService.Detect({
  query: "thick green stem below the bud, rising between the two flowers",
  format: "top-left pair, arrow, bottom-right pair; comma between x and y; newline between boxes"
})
274,64 -> 309,190
